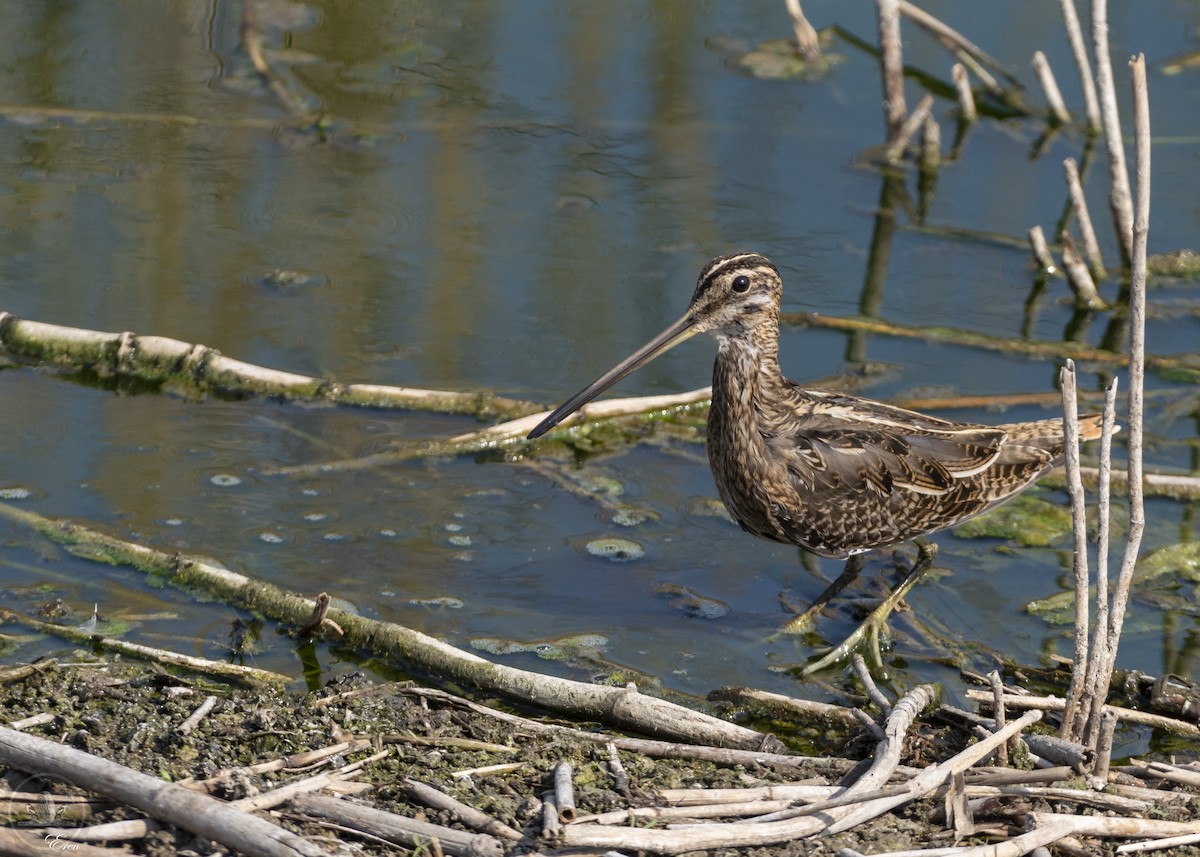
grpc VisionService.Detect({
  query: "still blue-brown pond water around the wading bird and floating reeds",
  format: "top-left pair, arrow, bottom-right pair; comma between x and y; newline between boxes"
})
0,1 -> 1200,715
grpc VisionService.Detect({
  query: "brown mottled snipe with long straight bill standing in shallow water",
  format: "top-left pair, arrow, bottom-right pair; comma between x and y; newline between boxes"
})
529,253 -> 1100,616
